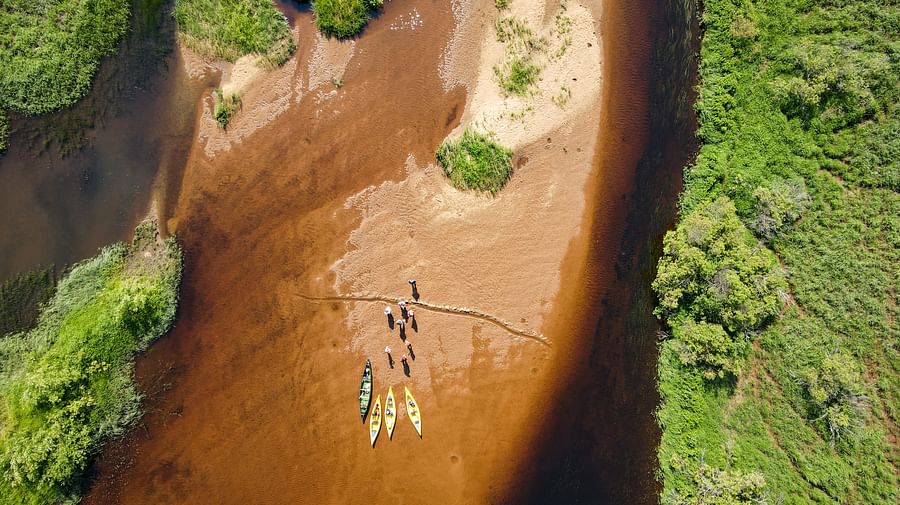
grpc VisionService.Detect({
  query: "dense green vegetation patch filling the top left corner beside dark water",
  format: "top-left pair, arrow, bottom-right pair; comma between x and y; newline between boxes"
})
0,0 -> 130,151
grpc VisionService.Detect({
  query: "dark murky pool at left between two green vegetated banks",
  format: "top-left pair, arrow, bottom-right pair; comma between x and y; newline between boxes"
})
0,0 -> 208,280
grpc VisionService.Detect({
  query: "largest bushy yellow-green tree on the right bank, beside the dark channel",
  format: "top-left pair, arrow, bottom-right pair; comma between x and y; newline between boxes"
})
653,197 -> 787,333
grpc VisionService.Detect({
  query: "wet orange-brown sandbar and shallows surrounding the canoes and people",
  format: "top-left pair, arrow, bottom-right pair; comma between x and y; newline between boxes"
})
87,2 -> 600,503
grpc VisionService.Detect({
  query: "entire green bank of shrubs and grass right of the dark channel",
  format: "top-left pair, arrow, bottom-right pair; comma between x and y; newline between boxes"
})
654,0 -> 900,504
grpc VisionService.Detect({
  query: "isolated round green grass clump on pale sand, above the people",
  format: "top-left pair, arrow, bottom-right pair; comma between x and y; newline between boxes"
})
436,128 -> 512,194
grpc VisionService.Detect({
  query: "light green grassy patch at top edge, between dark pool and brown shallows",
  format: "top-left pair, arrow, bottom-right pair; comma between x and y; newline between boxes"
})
175,0 -> 295,67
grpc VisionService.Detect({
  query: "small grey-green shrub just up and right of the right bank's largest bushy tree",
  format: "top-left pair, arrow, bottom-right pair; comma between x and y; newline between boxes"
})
750,178 -> 810,240
